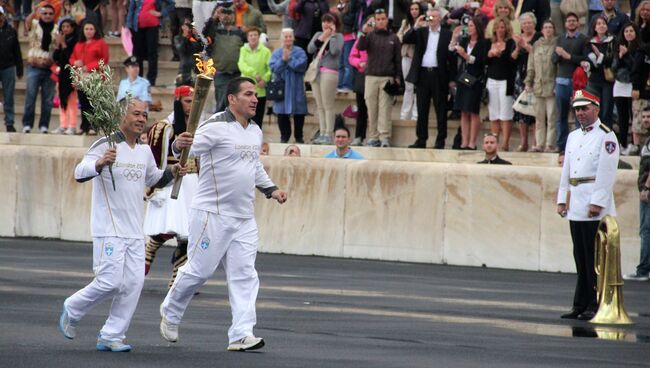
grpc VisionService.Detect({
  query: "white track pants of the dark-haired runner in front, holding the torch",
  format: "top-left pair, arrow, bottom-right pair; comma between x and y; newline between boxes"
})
163,210 -> 260,342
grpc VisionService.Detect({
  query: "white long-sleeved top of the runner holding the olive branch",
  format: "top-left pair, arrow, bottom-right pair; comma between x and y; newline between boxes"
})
74,132 -> 172,239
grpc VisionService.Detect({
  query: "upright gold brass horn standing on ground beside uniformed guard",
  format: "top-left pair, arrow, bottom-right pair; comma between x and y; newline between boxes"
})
589,215 -> 634,325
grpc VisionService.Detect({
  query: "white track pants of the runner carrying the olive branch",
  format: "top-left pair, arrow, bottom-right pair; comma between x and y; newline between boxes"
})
66,238 -> 144,341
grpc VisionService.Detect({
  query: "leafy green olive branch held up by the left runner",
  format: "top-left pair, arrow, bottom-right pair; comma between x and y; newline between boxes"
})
66,60 -> 131,190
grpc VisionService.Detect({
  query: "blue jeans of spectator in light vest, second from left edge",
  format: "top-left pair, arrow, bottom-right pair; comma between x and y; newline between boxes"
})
23,66 -> 56,128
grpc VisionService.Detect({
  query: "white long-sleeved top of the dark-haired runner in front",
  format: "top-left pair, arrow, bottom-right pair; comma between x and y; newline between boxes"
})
174,109 -> 277,218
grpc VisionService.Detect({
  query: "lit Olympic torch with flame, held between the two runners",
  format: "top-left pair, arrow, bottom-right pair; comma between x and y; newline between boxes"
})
171,54 -> 217,199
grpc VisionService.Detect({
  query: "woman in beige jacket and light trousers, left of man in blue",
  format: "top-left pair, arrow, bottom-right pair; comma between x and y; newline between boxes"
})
525,20 -> 557,152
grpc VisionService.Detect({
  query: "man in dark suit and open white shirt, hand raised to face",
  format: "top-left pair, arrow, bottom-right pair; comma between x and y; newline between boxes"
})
403,9 -> 456,149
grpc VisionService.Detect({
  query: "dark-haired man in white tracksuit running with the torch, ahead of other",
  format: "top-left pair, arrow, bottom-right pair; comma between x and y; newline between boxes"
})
160,77 -> 287,351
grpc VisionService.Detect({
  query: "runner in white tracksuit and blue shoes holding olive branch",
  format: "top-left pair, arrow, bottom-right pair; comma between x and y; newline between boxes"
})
59,99 -> 186,352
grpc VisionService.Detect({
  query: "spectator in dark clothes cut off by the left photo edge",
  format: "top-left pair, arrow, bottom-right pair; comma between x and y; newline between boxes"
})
0,6 -> 23,132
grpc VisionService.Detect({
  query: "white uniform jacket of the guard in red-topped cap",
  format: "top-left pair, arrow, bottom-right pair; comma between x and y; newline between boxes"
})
557,119 -> 620,221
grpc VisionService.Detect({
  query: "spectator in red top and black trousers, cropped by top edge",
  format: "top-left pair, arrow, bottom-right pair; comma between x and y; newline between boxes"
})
126,0 -> 174,86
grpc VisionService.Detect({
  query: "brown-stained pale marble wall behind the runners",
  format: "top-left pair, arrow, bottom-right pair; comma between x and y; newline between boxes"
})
0,145 -> 639,272
